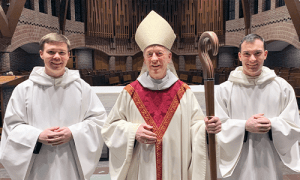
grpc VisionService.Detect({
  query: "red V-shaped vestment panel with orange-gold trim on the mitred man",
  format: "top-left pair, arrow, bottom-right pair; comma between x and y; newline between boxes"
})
125,80 -> 190,180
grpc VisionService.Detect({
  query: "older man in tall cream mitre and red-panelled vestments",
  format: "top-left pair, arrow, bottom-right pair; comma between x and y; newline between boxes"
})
102,11 -> 221,180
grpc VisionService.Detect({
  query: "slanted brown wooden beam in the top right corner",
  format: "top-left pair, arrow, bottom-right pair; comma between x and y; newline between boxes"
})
285,0 -> 300,41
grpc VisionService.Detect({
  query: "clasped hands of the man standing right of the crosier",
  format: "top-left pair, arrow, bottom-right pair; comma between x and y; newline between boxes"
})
245,114 -> 271,134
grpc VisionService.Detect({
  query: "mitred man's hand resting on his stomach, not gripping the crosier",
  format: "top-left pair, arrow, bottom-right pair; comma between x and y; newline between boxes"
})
135,123 -> 157,144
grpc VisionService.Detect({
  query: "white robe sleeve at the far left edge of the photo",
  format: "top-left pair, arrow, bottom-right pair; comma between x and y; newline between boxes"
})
0,83 -> 42,180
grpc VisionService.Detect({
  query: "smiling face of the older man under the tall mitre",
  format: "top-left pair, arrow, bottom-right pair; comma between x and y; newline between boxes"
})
144,45 -> 172,79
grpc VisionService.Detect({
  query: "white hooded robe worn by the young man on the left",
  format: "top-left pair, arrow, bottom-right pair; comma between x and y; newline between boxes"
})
0,67 -> 106,180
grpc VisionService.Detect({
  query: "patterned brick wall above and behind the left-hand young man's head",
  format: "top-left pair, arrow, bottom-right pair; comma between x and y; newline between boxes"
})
0,0 -> 85,52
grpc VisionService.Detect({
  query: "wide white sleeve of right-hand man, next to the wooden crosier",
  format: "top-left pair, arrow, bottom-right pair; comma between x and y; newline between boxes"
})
215,81 -> 247,177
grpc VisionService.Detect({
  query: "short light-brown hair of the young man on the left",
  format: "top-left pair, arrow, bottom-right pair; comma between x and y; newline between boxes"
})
39,33 -> 71,51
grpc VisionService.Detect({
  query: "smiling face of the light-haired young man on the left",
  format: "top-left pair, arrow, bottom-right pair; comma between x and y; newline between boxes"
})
40,42 -> 70,78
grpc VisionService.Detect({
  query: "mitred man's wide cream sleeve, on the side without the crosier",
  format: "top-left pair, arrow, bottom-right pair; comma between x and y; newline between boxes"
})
102,90 -> 140,180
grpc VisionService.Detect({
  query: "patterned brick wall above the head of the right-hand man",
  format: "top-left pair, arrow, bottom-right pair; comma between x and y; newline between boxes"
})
225,0 -> 300,49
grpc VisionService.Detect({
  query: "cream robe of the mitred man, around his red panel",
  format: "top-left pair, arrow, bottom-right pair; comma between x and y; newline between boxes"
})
102,76 -> 210,180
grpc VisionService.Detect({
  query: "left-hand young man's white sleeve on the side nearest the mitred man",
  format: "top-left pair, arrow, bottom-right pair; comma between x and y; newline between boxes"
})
69,82 -> 107,180
